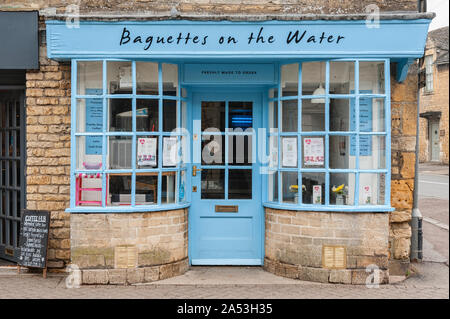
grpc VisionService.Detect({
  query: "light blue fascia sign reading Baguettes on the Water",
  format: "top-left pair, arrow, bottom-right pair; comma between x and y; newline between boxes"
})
47,19 -> 430,61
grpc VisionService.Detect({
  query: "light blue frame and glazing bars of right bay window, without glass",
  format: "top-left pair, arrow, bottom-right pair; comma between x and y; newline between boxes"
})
263,58 -> 394,212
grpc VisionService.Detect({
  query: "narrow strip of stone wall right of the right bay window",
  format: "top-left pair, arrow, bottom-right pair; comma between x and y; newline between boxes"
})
389,64 -> 418,275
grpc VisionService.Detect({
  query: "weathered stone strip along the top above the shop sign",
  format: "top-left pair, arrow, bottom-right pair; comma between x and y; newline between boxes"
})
0,0 -> 417,14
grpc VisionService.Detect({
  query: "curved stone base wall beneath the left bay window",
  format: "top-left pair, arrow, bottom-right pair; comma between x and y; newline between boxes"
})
70,209 -> 188,284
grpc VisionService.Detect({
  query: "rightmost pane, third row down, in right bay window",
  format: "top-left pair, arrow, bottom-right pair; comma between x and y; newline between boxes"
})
359,135 -> 386,169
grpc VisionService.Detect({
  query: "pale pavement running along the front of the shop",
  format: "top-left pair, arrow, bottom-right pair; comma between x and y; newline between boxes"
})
0,262 -> 449,299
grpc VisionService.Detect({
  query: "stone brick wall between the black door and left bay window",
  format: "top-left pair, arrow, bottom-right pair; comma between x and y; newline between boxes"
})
26,23 -> 70,269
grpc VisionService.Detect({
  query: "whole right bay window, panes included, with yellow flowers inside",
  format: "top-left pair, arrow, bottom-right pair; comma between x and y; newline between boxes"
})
267,60 -> 390,209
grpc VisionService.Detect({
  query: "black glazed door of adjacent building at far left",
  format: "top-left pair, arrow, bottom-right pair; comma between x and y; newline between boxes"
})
0,87 -> 26,261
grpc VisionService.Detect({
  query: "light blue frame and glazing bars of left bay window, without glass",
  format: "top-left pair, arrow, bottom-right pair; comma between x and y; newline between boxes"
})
66,59 -> 189,213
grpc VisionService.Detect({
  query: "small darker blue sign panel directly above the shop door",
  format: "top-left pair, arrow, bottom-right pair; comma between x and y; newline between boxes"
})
183,63 -> 276,84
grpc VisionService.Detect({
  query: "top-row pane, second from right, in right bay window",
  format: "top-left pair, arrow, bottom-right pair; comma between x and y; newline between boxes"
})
330,61 -> 355,94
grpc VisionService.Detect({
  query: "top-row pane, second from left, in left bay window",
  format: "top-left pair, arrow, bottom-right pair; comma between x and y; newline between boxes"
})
106,61 -> 133,94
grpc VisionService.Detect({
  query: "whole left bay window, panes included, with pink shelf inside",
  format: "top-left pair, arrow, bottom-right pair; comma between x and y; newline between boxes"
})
71,61 -> 186,209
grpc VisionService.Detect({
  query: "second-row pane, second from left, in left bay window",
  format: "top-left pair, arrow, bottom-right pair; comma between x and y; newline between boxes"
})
108,99 -> 133,132
